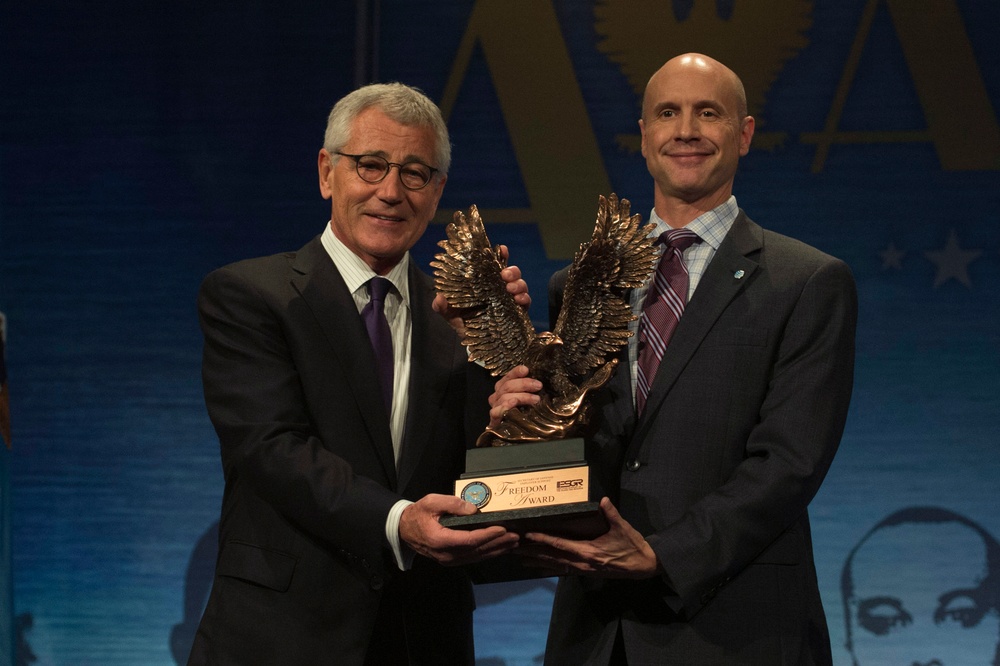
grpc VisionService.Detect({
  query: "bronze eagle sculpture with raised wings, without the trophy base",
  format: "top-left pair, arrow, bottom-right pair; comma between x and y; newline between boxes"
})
431,194 -> 659,446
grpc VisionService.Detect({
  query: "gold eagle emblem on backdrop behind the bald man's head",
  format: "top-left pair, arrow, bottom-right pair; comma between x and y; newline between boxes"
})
594,0 -> 813,147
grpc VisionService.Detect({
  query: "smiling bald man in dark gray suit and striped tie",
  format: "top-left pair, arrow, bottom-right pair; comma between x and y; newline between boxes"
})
491,54 -> 857,666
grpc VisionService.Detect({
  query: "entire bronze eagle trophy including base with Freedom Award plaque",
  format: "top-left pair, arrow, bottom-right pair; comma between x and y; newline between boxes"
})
431,194 -> 659,538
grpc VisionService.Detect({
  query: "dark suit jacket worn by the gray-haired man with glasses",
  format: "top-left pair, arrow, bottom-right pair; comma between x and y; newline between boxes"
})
190,238 -> 489,665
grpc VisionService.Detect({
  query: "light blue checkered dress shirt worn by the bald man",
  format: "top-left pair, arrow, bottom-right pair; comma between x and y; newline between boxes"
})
628,196 -> 740,404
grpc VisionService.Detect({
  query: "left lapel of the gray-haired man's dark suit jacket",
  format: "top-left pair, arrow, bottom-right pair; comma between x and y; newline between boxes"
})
292,238 -> 396,485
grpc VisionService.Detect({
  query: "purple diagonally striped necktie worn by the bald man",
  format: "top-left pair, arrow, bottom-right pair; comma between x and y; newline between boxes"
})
635,228 -> 701,414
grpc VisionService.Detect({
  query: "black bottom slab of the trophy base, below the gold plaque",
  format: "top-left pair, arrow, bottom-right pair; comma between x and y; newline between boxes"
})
441,502 -> 608,540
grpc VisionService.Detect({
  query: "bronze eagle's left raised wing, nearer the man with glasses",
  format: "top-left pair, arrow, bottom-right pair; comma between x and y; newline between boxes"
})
431,206 -> 535,376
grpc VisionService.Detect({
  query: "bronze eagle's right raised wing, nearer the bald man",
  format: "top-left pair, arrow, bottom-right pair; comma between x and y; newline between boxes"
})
553,194 -> 659,376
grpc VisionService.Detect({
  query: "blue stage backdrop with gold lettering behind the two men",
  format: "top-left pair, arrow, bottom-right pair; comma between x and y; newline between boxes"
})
0,0 -> 1000,666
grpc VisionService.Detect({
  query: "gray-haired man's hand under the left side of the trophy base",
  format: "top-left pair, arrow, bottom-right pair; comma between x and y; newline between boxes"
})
399,495 -> 518,566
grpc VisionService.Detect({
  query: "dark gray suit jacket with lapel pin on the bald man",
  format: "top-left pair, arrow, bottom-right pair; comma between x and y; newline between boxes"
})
546,211 -> 857,666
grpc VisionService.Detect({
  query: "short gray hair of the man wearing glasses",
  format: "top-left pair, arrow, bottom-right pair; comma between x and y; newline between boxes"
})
323,83 -> 451,175
